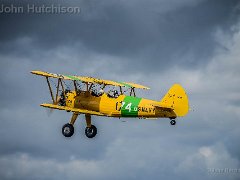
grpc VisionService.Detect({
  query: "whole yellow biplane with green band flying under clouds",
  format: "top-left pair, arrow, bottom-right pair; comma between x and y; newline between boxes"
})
31,71 -> 189,138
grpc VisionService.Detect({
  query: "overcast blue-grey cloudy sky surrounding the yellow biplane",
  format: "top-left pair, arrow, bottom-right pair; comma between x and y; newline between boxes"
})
0,0 -> 240,180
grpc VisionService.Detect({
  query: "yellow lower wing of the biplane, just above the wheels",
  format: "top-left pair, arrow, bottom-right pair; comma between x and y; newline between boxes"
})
40,104 -> 104,116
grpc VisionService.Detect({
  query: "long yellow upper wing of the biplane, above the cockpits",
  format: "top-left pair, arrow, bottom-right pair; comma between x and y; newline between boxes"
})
31,71 -> 150,89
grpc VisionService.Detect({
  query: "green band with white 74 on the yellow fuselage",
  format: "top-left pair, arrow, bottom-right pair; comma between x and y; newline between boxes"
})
121,96 -> 142,117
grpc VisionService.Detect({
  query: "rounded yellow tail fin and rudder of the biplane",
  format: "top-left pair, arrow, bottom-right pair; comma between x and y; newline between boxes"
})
160,84 -> 189,116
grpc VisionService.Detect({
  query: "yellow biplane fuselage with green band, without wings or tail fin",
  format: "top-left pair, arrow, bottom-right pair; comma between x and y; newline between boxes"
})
66,91 -> 176,118
